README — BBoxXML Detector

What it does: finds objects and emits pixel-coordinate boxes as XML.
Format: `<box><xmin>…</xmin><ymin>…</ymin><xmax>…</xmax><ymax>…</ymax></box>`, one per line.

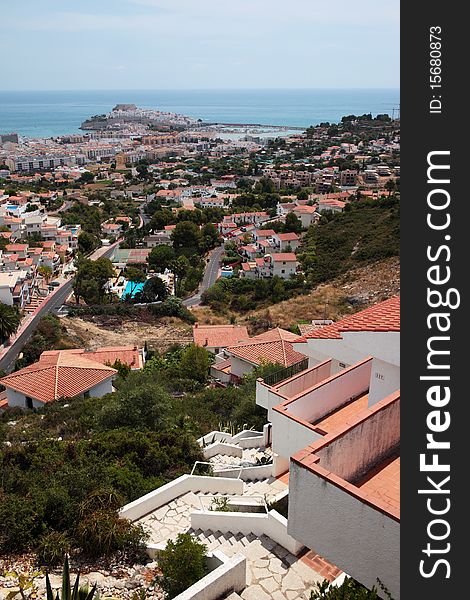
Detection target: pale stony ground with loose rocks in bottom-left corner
<box><xmin>0</xmin><ymin>555</ymin><xmax>164</xmax><ymax>600</ymax></box>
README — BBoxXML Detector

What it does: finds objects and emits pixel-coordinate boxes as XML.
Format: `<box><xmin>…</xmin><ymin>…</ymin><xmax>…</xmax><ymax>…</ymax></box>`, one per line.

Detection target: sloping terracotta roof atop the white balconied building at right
<box><xmin>297</xmin><ymin>296</ymin><xmax>400</xmax><ymax>342</ymax></box>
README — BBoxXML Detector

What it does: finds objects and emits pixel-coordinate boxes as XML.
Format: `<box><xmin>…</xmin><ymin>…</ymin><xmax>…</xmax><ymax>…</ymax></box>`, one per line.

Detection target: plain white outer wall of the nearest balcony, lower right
<box><xmin>288</xmin><ymin>463</ymin><xmax>400</xmax><ymax>600</ymax></box>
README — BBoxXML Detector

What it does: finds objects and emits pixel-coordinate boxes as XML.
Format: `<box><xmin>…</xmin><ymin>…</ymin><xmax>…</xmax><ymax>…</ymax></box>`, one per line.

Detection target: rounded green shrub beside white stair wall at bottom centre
<box><xmin>158</xmin><ymin>533</ymin><xmax>208</xmax><ymax>599</ymax></box>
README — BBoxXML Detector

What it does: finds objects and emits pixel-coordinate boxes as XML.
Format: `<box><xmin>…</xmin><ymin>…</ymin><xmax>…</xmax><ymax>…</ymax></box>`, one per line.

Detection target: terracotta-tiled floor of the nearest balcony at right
<box><xmin>354</xmin><ymin>454</ymin><xmax>400</xmax><ymax>510</ymax></box>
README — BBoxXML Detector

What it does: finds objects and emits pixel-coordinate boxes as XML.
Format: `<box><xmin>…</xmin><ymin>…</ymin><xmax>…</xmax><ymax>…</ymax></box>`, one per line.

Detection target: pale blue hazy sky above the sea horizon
<box><xmin>0</xmin><ymin>0</ymin><xmax>399</xmax><ymax>90</ymax></box>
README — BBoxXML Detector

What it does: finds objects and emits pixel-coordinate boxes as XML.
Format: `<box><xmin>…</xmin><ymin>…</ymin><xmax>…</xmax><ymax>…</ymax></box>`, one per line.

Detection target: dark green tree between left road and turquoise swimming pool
<box><xmin>73</xmin><ymin>258</ymin><xmax>114</xmax><ymax>304</ymax></box>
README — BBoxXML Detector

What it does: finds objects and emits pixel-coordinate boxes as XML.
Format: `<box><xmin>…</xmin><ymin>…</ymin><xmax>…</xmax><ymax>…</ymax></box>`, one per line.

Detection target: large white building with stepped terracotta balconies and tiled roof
<box><xmin>256</xmin><ymin>297</ymin><xmax>400</xmax><ymax>598</ymax></box>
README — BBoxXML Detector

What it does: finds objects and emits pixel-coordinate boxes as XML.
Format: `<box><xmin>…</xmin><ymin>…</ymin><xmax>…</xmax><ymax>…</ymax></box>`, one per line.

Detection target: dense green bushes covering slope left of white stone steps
<box><xmin>0</xmin><ymin>350</ymin><xmax>272</xmax><ymax>564</ymax></box>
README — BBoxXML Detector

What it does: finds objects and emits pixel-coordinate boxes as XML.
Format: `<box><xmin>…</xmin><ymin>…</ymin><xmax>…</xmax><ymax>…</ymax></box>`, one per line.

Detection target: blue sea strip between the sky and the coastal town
<box><xmin>0</xmin><ymin>89</ymin><xmax>400</xmax><ymax>137</ymax></box>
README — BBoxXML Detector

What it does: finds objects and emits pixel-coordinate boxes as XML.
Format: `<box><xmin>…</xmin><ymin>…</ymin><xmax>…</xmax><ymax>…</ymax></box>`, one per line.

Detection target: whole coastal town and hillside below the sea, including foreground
<box><xmin>0</xmin><ymin>103</ymin><xmax>400</xmax><ymax>600</ymax></box>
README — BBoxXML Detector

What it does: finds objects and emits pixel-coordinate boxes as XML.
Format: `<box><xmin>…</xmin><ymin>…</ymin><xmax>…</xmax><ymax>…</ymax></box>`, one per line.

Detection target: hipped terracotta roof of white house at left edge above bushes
<box><xmin>0</xmin><ymin>351</ymin><xmax>117</xmax><ymax>403</ymax></box>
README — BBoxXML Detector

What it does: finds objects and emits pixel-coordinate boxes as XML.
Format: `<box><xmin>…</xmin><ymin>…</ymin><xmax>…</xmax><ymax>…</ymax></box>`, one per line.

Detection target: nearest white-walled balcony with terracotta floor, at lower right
<box><xmin>288</xmin><ymin>391</ymin><xmax>400</xmax><ymax>600</ymax></box>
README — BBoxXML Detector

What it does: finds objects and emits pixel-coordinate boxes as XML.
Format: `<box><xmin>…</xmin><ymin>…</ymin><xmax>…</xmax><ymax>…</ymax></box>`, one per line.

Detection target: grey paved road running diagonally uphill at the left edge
<box><xmin>0</xmin><ymin>242</ymin><xmax>118</xmax><ymax>372</ymax></box>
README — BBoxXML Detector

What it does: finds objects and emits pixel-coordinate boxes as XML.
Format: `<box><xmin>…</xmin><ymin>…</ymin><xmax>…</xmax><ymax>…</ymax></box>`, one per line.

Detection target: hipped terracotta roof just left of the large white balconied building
<box><xmin>227</xmin><ymin>327</ymin><xmax>305</xmax><ymax>367</ymax></box>
